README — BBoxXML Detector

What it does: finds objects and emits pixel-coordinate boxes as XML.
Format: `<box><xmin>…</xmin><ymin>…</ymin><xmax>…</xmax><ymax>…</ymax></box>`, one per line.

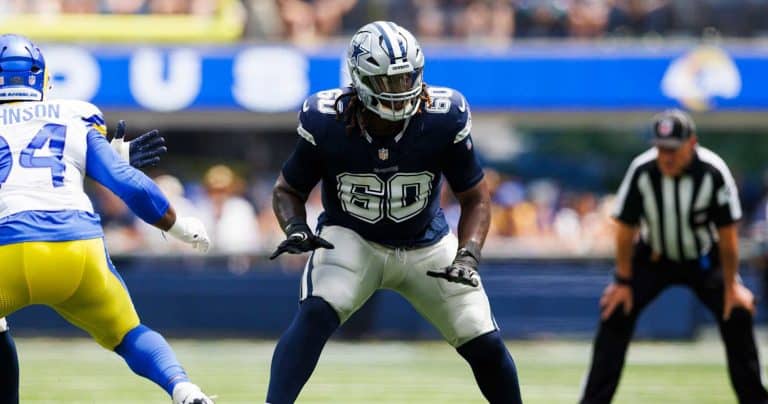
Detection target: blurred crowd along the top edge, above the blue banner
<box><xmin>0</xmin><ymin>0</ymin><xmax>768</xmax><ymax>40</ymax></box>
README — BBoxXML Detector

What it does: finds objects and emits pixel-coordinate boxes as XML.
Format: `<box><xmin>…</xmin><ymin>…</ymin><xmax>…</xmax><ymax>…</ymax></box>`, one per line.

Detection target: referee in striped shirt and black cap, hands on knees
<box><xmin>581</xmin><ymin>110</ymin><xmax>768</xmax><ymax>403</ymax></box>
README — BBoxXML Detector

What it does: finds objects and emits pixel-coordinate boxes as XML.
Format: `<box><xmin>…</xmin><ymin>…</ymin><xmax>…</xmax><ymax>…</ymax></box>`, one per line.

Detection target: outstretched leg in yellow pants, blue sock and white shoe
<box><xmin>52</xmin><ymin>239</ymin><xmax>210</xmax><ymax>404</ymax></box>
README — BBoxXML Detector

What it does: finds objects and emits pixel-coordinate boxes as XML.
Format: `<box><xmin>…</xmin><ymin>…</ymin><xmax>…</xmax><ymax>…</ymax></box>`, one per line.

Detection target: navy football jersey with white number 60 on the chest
<box><xmin>282</xmin><ymin>87</ymin><xmax>483</xmax><ymax>248</ymax></box>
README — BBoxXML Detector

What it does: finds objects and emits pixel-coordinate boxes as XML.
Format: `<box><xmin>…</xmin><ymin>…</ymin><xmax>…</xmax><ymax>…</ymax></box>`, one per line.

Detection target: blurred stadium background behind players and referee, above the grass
<box><xmin>0</xmin><ymin>0</ymin><xmax>768</xmax><ymax>402</ymax></box>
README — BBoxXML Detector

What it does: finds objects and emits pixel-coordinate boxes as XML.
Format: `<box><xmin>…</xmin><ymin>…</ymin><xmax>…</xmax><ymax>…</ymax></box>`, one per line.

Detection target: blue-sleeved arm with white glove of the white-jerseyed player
<box><xmin>86</xmin><ymin>130</ymin><xmax>210</xmax><ymax>252</ymax></box>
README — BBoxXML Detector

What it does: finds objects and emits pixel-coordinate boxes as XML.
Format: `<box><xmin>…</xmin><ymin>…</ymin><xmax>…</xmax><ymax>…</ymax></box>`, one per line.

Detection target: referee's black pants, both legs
<box><xmin>580</xmin><ymin>257</ymin><xmax>768</xmax><ymax>404</ymax></box>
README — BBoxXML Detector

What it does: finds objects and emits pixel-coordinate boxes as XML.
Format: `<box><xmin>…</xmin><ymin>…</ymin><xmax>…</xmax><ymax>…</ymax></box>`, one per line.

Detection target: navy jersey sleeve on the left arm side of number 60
<box><xmin>282</xmin><ymin>95</ymin><xmax>327</xmax><ymax>194</ymax></box>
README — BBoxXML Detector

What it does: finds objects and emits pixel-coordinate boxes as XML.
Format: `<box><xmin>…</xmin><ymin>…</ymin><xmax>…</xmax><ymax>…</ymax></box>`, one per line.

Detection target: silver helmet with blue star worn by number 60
<box><xmin>347</xmin><ymin>21</ymin><xmax>424</xmax><ymax>121</ymax></box>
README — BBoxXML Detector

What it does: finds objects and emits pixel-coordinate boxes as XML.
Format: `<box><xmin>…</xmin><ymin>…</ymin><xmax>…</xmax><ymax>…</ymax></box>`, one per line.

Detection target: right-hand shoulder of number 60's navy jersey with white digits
<box><xmin>424</xmin><ymin>87</ymin><xmax>472</xmax><ymax>143</ymax></box>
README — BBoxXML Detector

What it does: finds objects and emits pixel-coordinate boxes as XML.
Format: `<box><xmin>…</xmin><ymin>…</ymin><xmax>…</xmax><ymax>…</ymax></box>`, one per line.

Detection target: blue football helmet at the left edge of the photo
<box><xmin>0</xmin><ymin>34</ymin><xmax>48</xmax><ymax>102</ymax></box>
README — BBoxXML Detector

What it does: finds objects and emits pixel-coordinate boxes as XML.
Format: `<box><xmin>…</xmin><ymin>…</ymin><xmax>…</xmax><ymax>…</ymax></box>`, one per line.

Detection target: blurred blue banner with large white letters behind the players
<box><xmin>44</xmin><ymin>43</ymin><xmax>768</xmax><ymax>112</ymax></box>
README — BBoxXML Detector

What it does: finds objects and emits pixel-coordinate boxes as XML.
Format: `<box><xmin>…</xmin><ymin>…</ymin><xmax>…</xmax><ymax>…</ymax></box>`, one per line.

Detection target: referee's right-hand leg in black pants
<box><xmin>692</xmin><ymin>269</ymin><xmax>768</xmax><ymax>403</ymax></box>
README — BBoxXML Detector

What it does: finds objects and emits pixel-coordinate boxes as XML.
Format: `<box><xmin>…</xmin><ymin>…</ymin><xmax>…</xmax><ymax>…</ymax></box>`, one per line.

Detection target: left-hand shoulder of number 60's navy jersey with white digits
<box><xmin>296</xmin><ymin>88</ymin><xmax>343</xmax><ymax>146</ymax></box>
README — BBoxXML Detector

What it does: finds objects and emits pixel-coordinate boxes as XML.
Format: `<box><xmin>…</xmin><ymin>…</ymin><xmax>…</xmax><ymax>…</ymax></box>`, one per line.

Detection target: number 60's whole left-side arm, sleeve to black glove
<box><xmin>269</xmin><ymin>107</ymin><xmax>333</xmax><ymax>259</ymax></box>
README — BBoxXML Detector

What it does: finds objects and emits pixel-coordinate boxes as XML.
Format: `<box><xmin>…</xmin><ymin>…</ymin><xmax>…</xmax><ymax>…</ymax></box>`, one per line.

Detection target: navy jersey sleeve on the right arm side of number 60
<box><xmin>442</xmin><ymin>92</ymin><xmax>483</xmax><ymax>192</ymax></box>
